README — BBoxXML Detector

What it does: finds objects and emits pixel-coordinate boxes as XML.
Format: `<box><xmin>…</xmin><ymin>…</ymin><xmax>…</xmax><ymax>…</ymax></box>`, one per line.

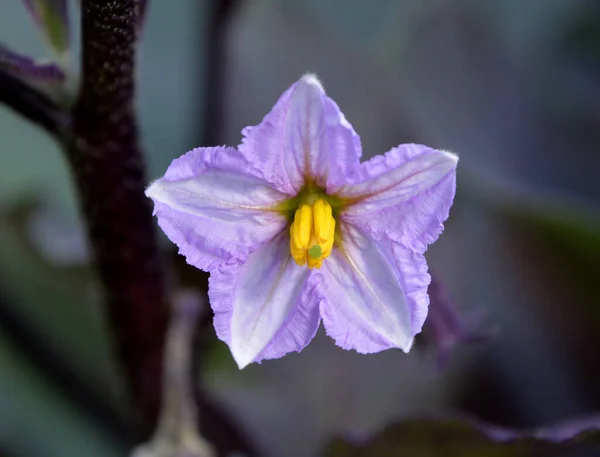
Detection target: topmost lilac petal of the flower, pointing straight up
<box><xmin>239</xmin><ymin>75</ymin><xmax>361</xmax><ymax>195</ymax></box>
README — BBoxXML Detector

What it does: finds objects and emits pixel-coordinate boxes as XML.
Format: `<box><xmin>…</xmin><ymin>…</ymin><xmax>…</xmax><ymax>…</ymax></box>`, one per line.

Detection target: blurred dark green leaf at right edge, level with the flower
<box><xmin>463</xmin><ymin>175</ymin><xmax>600</xmax><ymax>331</ymax></box>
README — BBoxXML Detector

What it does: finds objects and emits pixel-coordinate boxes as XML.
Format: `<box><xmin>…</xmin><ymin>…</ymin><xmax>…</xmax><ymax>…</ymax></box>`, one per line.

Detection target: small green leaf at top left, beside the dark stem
<box><xmin>23</xmin><ymin>0</ymin><xmax>69</xmax><ymax>55</ymax></box>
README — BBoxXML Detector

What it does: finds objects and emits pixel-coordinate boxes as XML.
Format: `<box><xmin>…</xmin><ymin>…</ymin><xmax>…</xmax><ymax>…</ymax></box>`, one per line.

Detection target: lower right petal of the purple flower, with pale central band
<box><xmin>319</xmin><ymin>224</ymin><xmax>429</xmax><ymax>353</ymax></box>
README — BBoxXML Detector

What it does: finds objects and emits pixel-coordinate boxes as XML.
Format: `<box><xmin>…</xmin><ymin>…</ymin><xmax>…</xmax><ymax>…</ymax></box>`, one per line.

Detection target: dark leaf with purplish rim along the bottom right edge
<box><xmin>325</xmin><ymin>416</ymin><xmax>600</xmax><ymax>457</ymax></box>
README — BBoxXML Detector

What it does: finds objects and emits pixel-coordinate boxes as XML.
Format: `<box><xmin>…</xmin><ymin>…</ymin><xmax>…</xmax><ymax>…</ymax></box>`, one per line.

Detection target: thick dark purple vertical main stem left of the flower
<box><xmin>68</xmin><ymin>0</ymin><xmax>168</xmax><ymax>425</ymax></box>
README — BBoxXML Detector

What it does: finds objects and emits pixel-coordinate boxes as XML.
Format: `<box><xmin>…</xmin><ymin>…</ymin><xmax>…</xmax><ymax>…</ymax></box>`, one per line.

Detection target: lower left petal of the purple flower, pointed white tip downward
<box><xmin>208</xmin><ymin>233</ymin><xmax>319</xmax><ymax>369</ymax></box>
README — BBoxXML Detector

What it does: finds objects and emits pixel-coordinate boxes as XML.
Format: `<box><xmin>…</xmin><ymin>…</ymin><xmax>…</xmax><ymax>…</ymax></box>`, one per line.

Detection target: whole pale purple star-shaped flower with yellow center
<box><xmin>146</xmin><ymin>75</ymin><xmax>458</xmax><ymax>368</ymax></box>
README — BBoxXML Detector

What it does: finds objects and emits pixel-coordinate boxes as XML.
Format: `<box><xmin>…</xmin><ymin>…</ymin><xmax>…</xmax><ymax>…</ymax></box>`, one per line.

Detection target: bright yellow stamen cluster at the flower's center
<box><xmin>290</xmin><ymin>198</ymin><xmax>335</xmax><ymax>269</ymax></box>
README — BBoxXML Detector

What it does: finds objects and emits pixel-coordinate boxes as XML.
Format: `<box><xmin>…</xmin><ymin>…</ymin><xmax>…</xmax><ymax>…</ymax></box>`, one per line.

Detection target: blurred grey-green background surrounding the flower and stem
<box><xmin>0</xmin><ymin>0</ymin><xmax>600</xmax><ymax>457</ymax></box>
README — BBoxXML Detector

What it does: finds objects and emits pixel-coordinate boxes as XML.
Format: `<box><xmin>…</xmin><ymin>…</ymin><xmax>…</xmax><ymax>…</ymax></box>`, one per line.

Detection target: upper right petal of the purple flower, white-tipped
<box><xmin>338</xmin><ymin>144</ymin><xmax>458</xmax><ymax>252</ymax></box>
